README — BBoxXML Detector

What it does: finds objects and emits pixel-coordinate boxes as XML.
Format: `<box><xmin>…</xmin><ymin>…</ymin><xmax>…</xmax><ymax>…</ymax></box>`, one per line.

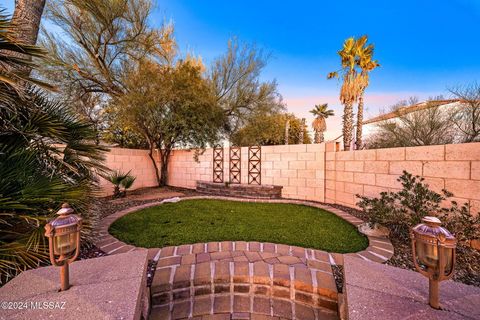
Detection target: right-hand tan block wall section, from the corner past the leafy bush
<box><xmin>325</xmin><ymin>143</ymin><xmax>480</xmax><ymax>213</ymax></box>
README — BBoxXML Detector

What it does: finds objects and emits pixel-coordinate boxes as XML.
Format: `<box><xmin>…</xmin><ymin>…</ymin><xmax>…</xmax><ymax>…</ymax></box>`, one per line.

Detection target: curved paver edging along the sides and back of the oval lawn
<box><xmin>95</xmin><ymin>196</ymin><xmax>394</xmax><ymax>264</ymax></box>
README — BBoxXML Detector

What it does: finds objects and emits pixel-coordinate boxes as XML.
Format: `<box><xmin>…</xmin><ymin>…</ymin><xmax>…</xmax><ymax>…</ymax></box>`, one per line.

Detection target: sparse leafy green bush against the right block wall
<box><xmin>357</xmin><ymin>171</ymin><xmax>480</xmax><ymax>244</ymax></box>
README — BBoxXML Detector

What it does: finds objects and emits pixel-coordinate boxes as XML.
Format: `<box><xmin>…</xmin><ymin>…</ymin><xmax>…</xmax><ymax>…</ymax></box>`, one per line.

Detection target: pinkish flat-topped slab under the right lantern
<box><xmin>344</xmin><ymin>257</ymin><xmax>480</xmax><ymax>320</ymax></box>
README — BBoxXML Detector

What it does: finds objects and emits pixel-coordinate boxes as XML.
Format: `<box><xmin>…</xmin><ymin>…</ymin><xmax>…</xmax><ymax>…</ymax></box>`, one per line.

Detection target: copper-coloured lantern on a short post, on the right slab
<box><xmin>410</xmin><ymin>217</ymin><xmax>457</xmax><ymax>309</ymax></box>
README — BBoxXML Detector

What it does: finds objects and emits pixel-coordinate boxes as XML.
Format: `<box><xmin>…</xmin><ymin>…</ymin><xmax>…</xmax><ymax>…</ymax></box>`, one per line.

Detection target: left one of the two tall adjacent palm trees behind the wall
<box><xmin>327</xmin><ymin>37</ymin><xmax>361</xmax><ymax>150</ymax></box>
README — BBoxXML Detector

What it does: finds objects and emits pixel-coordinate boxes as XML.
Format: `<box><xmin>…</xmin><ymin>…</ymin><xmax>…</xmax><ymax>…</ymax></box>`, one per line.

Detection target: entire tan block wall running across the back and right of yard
<box><xmin>102</xmin><ymin>143</ymin><xmax>480</xmax><ymax>213</ymax></box>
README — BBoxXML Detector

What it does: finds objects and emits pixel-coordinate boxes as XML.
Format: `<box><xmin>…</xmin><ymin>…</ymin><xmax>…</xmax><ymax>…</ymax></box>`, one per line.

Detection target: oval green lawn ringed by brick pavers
<box><xmin>109</xmin><ymin>199</ymin><xmax>368</xmax><ymax>253</ymax></box>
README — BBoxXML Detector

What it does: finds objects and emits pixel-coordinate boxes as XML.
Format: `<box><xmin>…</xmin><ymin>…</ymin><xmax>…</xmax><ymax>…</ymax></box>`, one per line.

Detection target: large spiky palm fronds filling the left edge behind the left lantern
<box><xmin>0</xmin><ymin>6</ymin><xmax>106</xmax><ymax>283</ymax></box>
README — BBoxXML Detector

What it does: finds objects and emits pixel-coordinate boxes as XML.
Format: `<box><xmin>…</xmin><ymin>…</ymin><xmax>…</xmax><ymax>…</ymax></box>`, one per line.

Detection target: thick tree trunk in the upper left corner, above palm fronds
<box><xmin>12</xmin><ymin>0</ymin><xmax>45</xmax><ymax>76</ymax></box>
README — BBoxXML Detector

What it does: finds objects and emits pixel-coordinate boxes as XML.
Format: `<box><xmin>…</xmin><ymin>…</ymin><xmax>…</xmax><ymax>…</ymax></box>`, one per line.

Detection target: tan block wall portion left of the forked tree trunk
<box><xmin>100</xmin><ymin>148</ymin><xmax>159</xmax><ymax>195</ymax></box>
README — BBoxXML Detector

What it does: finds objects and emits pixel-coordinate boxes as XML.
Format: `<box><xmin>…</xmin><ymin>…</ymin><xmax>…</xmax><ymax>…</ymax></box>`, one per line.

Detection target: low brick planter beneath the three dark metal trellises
<box><xmin>196</xmin><ymin>181</ymin><xmax>283</xmax><ymax>199</ymax></box>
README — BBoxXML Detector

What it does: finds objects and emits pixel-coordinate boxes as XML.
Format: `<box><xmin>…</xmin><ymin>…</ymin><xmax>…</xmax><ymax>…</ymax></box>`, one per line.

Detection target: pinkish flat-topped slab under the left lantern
<box><xmin>0</xmin><ymin>250</ymin><xmax>147</xmax><ymax>319</ymax></box>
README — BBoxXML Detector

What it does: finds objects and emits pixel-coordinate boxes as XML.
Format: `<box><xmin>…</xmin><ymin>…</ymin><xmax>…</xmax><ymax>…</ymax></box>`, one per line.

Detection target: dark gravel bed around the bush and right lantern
<box><xmin>327</xmin><ymin>203</ymin><xmax>480</xmax><ymax>287</ymax></box>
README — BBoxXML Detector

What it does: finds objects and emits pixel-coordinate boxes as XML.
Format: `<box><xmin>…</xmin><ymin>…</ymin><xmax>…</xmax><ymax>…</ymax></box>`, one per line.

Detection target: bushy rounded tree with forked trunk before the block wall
<box><xmin>112</xmin><ymin>58</ymin><xmax>224</xmax><ymax>186</ymax></box>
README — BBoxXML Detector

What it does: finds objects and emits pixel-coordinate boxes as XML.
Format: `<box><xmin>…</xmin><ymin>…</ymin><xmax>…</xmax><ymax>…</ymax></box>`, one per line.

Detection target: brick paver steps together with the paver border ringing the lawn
<box><xmin>96</xmin><ymin>196</ymin><xmax>393</xmax><ymax>320</ymax></box>
